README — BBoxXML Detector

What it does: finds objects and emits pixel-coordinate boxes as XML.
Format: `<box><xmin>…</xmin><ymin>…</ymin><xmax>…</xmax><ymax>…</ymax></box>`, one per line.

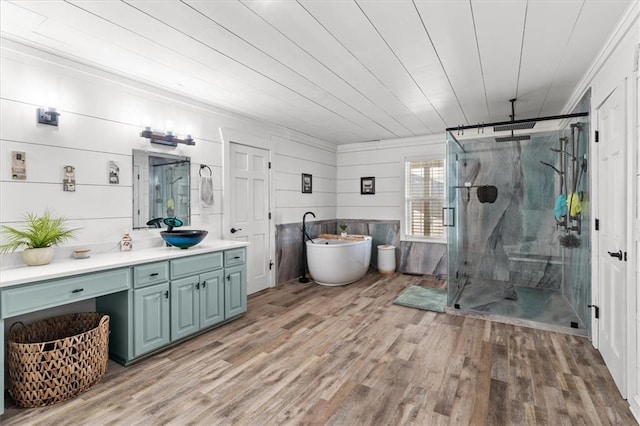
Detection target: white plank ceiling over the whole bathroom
<box><xmin>0</xmin><ymin>0</ymin><xmax>631</xmax><ymax>144</ymax></box>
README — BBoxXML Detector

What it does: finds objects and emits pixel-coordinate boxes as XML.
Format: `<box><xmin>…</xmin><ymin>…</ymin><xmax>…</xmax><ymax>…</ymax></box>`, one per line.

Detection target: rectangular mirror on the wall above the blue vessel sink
<box><xmin>133</xmin><ymin>150</ymin><xmax>191</xmax><ymax>229</ymax></box>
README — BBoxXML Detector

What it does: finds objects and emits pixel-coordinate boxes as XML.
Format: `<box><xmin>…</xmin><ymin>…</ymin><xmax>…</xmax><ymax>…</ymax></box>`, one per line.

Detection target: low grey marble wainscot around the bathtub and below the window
<box><xmin>276</xmin><ymin>219</ymin><xmax>447</xmax><ymax>284</ymax></box>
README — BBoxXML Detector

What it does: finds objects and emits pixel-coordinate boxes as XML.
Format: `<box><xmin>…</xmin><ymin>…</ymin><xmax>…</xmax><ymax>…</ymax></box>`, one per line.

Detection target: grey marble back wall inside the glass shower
<box><xmin>450</xmin><ymin>134</ymin><xmax>562</xmax><ymax>289</ymax></box>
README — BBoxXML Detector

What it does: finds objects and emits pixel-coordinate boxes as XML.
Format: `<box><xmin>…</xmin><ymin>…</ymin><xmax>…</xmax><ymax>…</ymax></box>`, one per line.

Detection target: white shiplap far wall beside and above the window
<box><xmin>336</xmin><ymin>134</ymin><xmax>446</xmax><ymax>220</ymax></box>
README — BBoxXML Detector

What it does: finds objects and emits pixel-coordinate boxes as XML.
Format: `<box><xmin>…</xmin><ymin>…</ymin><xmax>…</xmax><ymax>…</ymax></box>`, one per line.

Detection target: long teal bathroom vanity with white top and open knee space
<box><xmin>0</xmin><ymin>241</ymin><xmax>248</xmax><ymax>414</ymax></box>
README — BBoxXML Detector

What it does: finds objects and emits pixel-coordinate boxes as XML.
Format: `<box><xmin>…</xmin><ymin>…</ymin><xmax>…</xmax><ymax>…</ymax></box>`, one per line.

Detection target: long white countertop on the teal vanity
<box><xmin>0</xmin><ymin>240</ymin><xmax>249</xmax><ymax>288</ymax></box>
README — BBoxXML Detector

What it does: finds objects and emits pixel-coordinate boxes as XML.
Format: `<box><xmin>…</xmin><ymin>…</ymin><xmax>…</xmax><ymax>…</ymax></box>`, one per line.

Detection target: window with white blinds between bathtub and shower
<box><xmin>405</xmin><ymin>159</ymin><xmax>446</xmax><ymax>239</ymax></box>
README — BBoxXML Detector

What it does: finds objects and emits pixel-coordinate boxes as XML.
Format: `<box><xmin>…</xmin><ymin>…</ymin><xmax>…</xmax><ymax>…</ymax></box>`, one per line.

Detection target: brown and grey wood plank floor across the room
<box><xmin>0</xmin><ymin>273</ymin><xmax>636</xmax><ymax>426</ymax></box>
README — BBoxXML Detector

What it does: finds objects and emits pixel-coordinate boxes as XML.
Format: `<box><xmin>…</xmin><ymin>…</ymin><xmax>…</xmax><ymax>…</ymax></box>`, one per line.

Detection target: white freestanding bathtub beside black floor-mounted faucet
<box><xmin>307</xmin><ymin>236</ymin><xmax>371</xmax><ymax>286</ymax></box>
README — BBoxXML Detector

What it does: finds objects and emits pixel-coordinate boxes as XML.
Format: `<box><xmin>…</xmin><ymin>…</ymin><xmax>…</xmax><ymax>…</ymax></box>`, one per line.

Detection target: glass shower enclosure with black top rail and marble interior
<box><xmin>443</xmin><ymin>118</ymin><xmax>590</xmax><ymax>334</ymax></box>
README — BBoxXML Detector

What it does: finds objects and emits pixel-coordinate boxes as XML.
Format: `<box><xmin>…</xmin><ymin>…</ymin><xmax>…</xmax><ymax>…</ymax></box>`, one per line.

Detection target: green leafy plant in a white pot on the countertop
<box><xmin>0</xmin><ymin>209</ymin><xmax>79</xmax><ymax>266</ymax></box>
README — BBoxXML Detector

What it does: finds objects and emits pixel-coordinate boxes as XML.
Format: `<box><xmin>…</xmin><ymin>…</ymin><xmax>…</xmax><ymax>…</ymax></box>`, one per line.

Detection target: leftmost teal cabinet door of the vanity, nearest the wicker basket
<box><xmin>133</xmin><ymin>283</ymin><xmax>170</xmax><ymax>356</ymax></box>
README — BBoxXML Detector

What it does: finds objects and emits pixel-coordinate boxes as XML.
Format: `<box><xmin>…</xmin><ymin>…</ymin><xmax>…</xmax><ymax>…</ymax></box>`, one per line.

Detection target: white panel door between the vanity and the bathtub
<box><xmin>229</xmin><ymin>143</ymin><xmax>271</xmax><ymax>294</ymax></box>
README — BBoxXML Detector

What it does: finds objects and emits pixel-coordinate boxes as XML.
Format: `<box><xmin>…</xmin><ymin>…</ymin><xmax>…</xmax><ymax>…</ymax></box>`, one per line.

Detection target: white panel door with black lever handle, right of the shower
<box><xmin>596</xmin><ymin>86</ymin><xmax>627</xmax><ymax>398</ymax></box>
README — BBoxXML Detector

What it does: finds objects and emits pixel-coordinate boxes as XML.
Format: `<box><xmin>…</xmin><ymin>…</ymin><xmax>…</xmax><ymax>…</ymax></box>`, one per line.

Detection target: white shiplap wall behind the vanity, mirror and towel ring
<box><xmin>0</xmin><ymin>39</ymin><xmax>336</xmax><ymax>267</ymax></box>
